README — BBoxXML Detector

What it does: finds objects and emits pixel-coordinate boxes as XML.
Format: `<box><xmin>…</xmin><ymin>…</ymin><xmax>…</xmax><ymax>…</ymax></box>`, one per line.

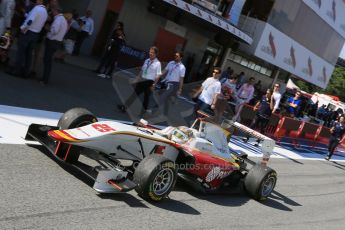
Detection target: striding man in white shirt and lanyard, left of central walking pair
<box><xmin>118</xmin><ymin>46</ymin><xmax>162</xmax><ymax>113</ymax></box>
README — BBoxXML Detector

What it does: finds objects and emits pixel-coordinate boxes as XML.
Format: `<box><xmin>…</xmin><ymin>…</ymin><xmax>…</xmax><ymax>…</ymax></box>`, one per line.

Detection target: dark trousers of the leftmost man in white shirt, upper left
<box><xmin>15</xmin><ymin>31</ymin><xmax>39</xmax><ymax>75</ymax></box>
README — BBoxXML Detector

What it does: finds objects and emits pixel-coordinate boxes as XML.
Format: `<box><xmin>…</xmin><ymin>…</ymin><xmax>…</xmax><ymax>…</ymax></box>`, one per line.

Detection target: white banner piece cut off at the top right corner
<box><xmin>303</xmin><ymin>0</ymin><xmax>345</xmax><ymax>38</ymax></box>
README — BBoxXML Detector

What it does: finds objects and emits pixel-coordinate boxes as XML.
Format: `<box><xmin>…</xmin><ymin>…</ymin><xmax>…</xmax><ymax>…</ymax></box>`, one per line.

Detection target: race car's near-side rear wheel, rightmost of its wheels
<box><xmin>244</xmin><ymin>164</ymin><xmax>277</xmax><ymax>201</ymax></box>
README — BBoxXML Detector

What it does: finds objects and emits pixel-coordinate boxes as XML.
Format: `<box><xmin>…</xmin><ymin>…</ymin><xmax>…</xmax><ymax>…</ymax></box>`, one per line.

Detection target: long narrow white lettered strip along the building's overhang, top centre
<box><xmin>163</xmin><ymin>0</ymin><xmax>253</xmax><ymax>45</ymax></box>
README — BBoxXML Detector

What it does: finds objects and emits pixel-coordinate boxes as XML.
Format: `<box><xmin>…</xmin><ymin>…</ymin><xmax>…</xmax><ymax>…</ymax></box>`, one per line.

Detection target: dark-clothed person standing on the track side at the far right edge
<box><xmin>325</xmin><ymin>116</ymin><xmax>345</xmax><ymax>160</ymax></box>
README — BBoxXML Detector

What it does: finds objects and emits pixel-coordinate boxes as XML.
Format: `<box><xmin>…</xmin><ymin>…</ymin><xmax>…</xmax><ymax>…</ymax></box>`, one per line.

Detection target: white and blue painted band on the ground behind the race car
<box><xmin>0</xmin><ymin>105</ymin><xmax>345</xmax><ymax>162</ymax></box>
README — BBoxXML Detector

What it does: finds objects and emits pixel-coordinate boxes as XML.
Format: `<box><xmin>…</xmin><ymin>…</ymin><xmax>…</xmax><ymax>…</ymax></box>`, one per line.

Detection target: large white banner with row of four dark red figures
<box><xmin>254</xmin><ymin>24</ymin><xmax>334</xmax><ymax>88</ymax></box>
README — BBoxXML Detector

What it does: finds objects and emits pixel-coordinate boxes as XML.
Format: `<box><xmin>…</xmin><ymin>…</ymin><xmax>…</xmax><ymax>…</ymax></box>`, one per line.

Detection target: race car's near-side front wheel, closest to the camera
<box><xmin>133</xmin><ymin>154</ymin><xmax>177</xmax><ymax>201</ymax></box>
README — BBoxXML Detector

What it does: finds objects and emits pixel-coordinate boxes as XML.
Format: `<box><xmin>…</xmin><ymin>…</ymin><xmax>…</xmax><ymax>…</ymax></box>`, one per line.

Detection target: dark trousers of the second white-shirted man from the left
<box><xmin>42</xmin><ymin>38</ymin><xmax>61</xmax><ymax>83</ymax></box>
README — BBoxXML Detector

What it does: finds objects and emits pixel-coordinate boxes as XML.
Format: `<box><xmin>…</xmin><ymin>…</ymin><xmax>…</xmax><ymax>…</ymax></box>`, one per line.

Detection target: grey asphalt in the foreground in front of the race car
<box><xmin>0</xmin><ymin>144</ymin><xmax>345</xmax><ymax>229</ymax></box>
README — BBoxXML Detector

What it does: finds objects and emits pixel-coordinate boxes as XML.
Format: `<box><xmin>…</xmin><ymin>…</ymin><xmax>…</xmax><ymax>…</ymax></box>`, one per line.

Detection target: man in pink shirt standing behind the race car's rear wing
<box><xmin>233</xmin><ymin>77</ymin><xmax>255</xmax><ymax>121</ymax></box>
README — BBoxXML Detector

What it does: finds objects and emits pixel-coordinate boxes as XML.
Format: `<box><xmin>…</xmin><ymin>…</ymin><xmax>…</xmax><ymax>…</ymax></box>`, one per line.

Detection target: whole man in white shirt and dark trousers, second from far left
<box><xmin>40</xmin><ymin>8</ymin><xmax>68</xmax><ymax>85</ymax></box>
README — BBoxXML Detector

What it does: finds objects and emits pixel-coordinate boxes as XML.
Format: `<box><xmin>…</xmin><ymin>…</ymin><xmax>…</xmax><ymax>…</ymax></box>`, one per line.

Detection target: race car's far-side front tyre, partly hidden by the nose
<box><xmin>57</xmin><ymin>108</ymin><xmax>98</xmax><ymax>164</ymax></box>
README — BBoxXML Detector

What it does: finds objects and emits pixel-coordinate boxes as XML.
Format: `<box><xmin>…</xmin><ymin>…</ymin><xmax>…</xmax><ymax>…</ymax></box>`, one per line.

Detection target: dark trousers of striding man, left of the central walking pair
<box><xmin>125</xmin><ymin>80</ymin><xmax>154</xmax><ymax>110</ymax></box>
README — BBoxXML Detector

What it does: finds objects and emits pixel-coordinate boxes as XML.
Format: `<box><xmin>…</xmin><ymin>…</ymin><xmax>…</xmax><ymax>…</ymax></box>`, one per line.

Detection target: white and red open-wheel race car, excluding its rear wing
<box><xmin>25</xmin><ymin>108</ymin><xmax>277</xmax><ymax>201</ymax></box>
